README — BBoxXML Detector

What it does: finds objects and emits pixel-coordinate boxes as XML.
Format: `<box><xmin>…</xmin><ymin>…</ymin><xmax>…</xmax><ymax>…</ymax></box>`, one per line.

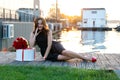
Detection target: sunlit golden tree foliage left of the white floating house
<box><xmin>47</xmin><ymin>4</ymin><xmax>81</xmax><ymax>25</ymax></box>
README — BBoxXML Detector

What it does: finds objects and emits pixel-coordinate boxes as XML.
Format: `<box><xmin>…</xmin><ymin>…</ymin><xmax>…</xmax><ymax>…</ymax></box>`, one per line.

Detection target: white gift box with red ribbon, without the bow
<box><xmin>16</xmin><ymin>48</ymin><xmax>35</xmax><ymax>61</ymax></box>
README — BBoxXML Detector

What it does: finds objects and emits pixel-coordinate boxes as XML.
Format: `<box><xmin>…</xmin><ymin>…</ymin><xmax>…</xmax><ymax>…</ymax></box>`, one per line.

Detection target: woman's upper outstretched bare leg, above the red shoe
<box><xmin>62</xmin><ymin>50</ymin><xmax>91</xmax><ymax>61</ymax></box>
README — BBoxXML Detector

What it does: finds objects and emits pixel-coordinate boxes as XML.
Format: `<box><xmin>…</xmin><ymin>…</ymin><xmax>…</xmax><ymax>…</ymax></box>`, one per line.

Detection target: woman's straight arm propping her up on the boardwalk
<box><xmin>44</xmin><ymin>30</ymin><xmax>52</xmax><ymax>59</ymax></box>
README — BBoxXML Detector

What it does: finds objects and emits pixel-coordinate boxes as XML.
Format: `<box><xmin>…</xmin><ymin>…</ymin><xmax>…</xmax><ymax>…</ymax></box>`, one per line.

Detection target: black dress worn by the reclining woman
<box><xmin>35</xmin><ymin>32</ymin><xmax>65</xmax><ymax>61</ymax></box>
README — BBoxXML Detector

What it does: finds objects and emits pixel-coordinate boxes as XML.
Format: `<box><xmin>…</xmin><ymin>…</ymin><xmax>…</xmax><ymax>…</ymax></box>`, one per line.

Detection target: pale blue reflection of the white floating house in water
<box><xmin>81</xmin><ymin>31</ymin><xmax>105</xmax><ymax>49</ymax></box>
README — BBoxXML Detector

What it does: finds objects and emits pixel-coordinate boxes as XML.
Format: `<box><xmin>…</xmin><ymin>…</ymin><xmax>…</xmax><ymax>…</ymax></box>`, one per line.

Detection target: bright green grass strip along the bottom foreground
<box><xmin>0</xmin><ymin>65</ymin><xmax>119</xmax><ymax>80</ymax></box>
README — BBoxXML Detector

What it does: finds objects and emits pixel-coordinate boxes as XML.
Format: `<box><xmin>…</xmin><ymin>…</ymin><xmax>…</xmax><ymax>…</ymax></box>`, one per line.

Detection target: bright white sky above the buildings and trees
<box><xmin>0</xmin><ymin>0</ymin><xmax>120</xmax><ymax>20</ymax></box>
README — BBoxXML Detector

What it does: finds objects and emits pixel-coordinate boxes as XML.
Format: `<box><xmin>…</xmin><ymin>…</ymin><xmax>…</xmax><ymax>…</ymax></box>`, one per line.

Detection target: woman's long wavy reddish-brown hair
<box><xmin>33</xmin><ymin>17</ymin><xmax>49</xmax><ymax>34</ymax></box>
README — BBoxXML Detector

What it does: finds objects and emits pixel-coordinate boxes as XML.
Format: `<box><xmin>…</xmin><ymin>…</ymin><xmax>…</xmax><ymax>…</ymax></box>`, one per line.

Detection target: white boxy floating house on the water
<box><xmin>81</xmin><ymin>8</ymin><xmax>107</xmax><ymax>28</ymax></box>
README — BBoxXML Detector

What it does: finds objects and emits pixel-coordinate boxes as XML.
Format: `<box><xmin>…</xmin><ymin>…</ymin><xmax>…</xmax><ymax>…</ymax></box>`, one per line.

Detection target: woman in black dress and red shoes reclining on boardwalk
<box><xmin>30</xmin><ymin>17</ymin><xmax>96</xmax><ymax>62</ymax></box>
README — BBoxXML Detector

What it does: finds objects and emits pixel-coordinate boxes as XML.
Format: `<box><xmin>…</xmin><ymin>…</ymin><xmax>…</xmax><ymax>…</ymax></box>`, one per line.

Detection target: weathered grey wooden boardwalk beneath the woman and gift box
<box><xmin>0</xmin><ymin>52</ymin><xmax>120</xmax><ymax>70</ymax></box>
